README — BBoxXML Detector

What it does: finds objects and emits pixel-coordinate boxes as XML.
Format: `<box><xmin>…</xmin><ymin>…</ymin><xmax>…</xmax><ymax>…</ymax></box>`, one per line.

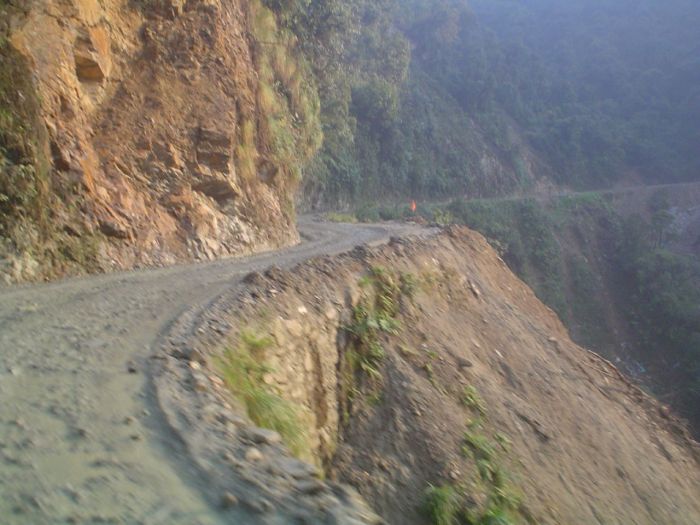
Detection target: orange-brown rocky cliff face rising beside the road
<box><xmin>0</xmin><ymin>0</ymin><xmax>320</xmax><ymax>280</ymax></box>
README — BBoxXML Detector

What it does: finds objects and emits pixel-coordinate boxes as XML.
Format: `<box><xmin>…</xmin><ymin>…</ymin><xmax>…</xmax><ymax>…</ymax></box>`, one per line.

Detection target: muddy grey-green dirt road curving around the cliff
<box><xmin>0</xmin><ymin>219</ymin><xmax>426</xmax><ymax>525</ymax></box>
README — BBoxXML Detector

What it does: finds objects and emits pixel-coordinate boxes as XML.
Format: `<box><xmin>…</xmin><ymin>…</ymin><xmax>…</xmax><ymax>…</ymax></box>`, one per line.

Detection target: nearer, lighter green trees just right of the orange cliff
<box><xmin>266</xmin><ymin>0</ymin><xmax>409</xmax><ymax>201</ymax></box>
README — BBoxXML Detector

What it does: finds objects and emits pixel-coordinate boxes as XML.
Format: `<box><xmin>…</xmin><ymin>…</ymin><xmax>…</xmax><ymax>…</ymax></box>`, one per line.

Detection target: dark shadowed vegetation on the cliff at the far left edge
<box><xmin>0</xmin><ymin>9</ymin><xmax>99</xmax><ymax>277</ymax></box>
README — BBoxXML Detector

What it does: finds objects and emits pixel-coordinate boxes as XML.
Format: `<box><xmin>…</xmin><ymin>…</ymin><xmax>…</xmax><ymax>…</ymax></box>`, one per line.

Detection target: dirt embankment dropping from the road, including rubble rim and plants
<box><xmin>156</xmin><ymin>225</ymin><xmax>700</xmax><ymax>525</ymax></box>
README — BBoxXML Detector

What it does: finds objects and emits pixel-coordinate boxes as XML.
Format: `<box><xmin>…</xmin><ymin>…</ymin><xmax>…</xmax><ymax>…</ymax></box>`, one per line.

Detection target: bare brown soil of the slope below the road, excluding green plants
<box><xmin>185</xmin><ymin>223</ymin><xmax>700</xmax><ymax>525</ymax></box>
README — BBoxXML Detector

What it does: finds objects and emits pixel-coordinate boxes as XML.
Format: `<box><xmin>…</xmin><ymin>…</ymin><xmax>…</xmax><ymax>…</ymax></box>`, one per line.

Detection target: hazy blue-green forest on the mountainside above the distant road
<box><xmin>267</xmin><ymin>0</ymin><xmax>700</xmax><ymax>205</ymax></box>
